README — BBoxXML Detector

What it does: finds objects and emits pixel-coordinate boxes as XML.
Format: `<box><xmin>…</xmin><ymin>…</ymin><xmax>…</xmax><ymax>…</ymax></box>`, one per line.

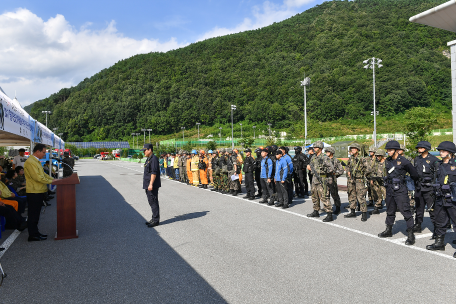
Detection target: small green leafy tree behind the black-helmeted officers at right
<box><xmin>404</xmin><ymin>107</ymin><xmax>437</xmax><ymax>150</ymax></box>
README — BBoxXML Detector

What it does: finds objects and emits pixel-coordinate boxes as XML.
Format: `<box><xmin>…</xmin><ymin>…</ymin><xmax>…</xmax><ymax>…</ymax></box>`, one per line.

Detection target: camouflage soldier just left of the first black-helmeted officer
<box><xmin>368</xmin><ymin>149</ymin><xmax>386</xmax><ymax>214</ymax></box>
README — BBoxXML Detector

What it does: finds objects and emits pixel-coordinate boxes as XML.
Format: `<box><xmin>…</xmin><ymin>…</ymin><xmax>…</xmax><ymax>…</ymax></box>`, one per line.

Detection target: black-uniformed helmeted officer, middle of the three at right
<box><xmin>413</xmin><ymin>141</ymin><xmax>439</xmax><ymax>233</ymax></box>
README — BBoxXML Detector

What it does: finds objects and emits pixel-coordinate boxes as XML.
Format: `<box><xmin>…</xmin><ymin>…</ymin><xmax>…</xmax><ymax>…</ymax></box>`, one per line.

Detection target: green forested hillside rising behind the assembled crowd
<box><xmin>26</xmin><ymin>0</ymin><xmax>456</xmax><ymax>141</ymax></box>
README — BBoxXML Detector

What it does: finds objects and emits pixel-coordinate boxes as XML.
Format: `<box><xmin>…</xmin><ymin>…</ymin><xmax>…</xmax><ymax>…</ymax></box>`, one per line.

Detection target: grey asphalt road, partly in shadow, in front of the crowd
<box><xmin>0</xmin><ymin>160</ymin><xmax>456</xmax><ymax>303</ymax></box>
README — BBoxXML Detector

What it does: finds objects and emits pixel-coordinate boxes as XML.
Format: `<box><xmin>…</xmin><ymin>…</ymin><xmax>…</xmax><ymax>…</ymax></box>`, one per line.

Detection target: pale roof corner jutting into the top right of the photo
<box><xmin>409</xmin><ymin>0</ymin><xmax>456</xmax><ymax>33</ymax></box>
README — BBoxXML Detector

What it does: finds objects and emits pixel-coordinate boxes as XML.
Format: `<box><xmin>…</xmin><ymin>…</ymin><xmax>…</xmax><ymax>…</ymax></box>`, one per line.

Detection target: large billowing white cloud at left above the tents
<box><xmin>0</xmin><ymin>9</ymin><xmax>186</xmax><ymax>106</ymax></box>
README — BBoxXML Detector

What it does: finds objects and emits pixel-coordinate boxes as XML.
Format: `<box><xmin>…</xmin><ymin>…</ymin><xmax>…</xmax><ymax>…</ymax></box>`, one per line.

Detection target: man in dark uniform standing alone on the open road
<box><xmin>141</xmin><ymin>144</ymin><xmax>161</xmax><ymax>228</ymax></box>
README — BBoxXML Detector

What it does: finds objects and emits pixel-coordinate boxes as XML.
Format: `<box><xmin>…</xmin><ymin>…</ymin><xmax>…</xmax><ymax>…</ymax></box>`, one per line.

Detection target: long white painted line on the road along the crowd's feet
<box><xmin>112</xmin><ymin>164</ymin><xmax>456</xmax><ymax>261</ymax></box>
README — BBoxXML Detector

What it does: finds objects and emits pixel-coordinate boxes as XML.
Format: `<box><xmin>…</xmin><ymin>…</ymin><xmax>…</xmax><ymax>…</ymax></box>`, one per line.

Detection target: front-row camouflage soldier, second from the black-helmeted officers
<box><xmin>344</xmin><ymin>143</ymin><xmax>369</xmax><ymax>222</ymax></box>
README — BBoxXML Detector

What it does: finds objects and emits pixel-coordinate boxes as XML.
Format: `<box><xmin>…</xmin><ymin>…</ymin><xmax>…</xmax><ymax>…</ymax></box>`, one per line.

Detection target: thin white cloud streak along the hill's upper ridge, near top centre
<box><xmin>198</xmin><ymin>0</ymin><xmax>315</xmax><ymax>41</ymax></box>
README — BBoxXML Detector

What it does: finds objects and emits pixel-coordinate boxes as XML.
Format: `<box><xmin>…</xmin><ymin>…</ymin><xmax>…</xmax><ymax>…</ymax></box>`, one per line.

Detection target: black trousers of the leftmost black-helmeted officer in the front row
<box><xmin>385</xmin><ymin>185</ymin><xmax>413</xmax><ymax>229</ymax></box>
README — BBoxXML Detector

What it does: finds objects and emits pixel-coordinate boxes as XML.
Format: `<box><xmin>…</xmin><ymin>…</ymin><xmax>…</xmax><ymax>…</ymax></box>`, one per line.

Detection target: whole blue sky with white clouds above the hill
<box><xmin>0</xmin><ymin>0</ymin><xmax>324</xmax><ymax>106</ymax></box>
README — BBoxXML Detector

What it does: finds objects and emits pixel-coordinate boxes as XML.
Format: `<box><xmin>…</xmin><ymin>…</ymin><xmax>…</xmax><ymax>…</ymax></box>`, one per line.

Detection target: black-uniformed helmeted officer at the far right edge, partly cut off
<box><xmin>426</xmin><ymin>141</ymin><xmax>456</xmax><ymax>258</ymax></box>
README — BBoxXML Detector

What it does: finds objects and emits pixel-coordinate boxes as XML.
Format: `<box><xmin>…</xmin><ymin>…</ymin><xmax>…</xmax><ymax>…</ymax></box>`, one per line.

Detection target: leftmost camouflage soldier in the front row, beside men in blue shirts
<box><xmin>307</xmin><ymin>141</ymin><xmax>334</xmax><ymax>222</ymax></box>
